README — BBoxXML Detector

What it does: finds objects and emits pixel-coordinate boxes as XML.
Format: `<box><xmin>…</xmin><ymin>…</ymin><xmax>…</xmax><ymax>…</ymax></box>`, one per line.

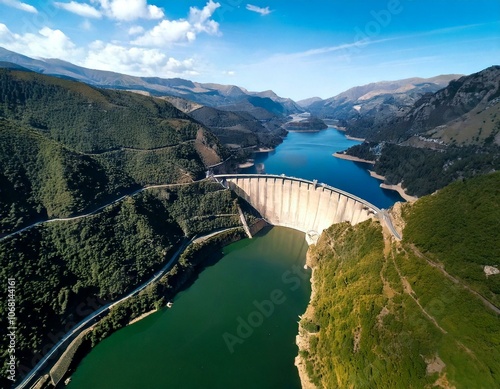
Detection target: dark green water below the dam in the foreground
<box><xmin>68</xmin><ymin>227</ymin><xmax>310</xmax><ymax>389</ymax></box>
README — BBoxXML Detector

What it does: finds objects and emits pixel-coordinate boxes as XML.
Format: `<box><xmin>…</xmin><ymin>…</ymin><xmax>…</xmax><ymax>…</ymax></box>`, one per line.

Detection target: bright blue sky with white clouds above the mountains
<box><xmin>0</xmin><ymin>0</ymin><xmax>500</xmax><ymax>100</ymax></box>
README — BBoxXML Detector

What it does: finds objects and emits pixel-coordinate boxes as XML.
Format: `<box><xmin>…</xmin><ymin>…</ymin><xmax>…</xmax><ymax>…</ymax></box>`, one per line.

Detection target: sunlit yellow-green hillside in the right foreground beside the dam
<box><xmin>300</xmin><ymin>173</ymin><xmax>500</xmax><ymax>388</ymax></box>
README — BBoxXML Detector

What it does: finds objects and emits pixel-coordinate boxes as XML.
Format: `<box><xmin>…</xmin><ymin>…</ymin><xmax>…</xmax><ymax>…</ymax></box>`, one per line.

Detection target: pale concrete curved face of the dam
<box><xmin>214</xmin><ymin>174</ymin><xmax>381</xmax><ymax>235</ymax></box>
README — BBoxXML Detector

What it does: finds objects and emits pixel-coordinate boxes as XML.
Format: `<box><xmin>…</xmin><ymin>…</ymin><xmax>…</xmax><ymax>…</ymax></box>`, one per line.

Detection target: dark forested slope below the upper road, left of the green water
<box><xmin>0</xmin><ymin>181</ymin><xmax>252</xmax><ymax>382</ymax></box>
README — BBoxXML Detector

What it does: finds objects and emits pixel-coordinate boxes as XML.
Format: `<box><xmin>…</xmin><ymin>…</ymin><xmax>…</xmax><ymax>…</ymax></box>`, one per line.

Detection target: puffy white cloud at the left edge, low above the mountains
<box><xmin>0</xmin><ymin>23</ymin><xmax>84</xmax><ymax>61</ymax></box>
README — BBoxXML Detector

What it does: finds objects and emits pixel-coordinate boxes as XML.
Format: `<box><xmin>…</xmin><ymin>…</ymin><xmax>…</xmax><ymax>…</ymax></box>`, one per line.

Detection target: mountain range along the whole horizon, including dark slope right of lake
<box><xmin>0</xmin><ymin>48</ymin><xmax>500</xmax><ymax>196</ymax></box>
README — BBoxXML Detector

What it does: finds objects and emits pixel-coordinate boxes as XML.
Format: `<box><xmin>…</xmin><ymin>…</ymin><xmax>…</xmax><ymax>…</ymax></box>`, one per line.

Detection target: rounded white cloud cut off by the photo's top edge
<box><xmin>91</xmin><ymin>0</ymin><xmax>165</xmax><ymax>21</ymax></box>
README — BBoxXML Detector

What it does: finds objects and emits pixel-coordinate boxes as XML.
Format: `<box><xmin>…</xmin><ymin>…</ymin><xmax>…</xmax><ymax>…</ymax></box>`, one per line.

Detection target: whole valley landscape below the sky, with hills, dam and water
<box><xmin>0</xmin><ymin>49</ymin><xmax>500</xmax><ymax>388</ymax></box>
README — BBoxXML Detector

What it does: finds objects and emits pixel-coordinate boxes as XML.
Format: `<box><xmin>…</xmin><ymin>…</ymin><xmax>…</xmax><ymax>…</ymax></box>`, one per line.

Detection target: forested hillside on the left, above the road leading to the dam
<box><xmin>0</xmin><ymin>69</ymin><xmax>227</xmax><ymax>233</ymax></box>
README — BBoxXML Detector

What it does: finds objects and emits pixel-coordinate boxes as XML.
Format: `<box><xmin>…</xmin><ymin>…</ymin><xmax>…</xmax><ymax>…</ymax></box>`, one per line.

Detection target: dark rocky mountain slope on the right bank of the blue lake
<box><xmin>346</xmin><ymin>66</ymin><xmax>500</xmax><ymax>196</ymax></box>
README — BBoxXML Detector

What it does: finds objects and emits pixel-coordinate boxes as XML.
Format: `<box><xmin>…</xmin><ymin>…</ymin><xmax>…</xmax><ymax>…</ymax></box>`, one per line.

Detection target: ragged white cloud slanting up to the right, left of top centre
<box><xmin>132</xmin><ymin>0</ymin><xmax>220</xmax><ymax>47</ymax></box>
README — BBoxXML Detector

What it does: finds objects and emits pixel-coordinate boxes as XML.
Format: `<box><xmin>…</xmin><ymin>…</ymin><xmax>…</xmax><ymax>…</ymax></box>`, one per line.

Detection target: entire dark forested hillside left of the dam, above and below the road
<box><xmin>0</xmin><ymin>69</ymin><xmax>252</xmax><ymax>387</ymax></box>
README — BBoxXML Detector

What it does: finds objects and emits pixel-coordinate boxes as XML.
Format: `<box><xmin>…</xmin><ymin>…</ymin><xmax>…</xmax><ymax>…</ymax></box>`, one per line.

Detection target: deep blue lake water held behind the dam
<box><xmin>241</xmin><ymin>127</ymin><xmax>404</xmax><ymax>208</ymax></box>
